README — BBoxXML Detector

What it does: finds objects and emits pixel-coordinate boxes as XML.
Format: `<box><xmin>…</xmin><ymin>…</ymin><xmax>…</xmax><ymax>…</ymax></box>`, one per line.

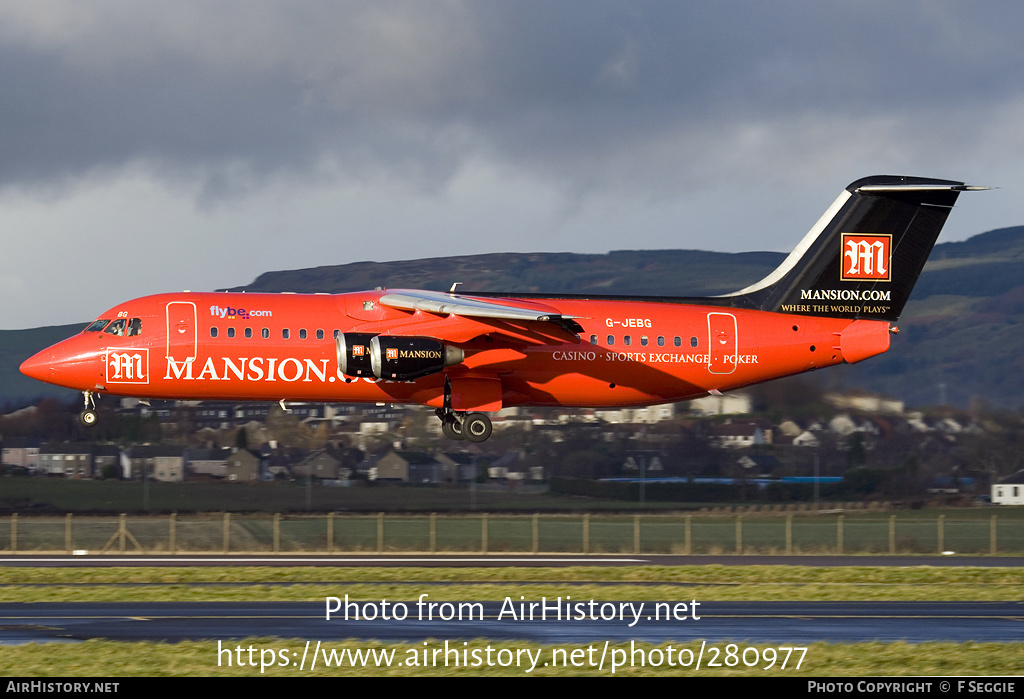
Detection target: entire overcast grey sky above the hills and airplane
<box><xmin>0</xmin><ymin>0</ymin><xmax>1024</xmax><ymax>329</ymax></box>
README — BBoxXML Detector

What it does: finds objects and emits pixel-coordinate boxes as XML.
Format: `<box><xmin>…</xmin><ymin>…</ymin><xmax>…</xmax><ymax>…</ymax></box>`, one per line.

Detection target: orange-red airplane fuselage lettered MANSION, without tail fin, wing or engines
<box><xmin>22</xmin><ymin>291</ymin><xmax>889</xmax><ymax>410</ymax></box>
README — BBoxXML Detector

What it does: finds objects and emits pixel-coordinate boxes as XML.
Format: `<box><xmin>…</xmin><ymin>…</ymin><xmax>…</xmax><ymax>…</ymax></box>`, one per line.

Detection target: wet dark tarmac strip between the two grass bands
<box><xmin>0</xmin><ymin>597</ymin><xmax>1024</xmax><ymax>644</ymax></box>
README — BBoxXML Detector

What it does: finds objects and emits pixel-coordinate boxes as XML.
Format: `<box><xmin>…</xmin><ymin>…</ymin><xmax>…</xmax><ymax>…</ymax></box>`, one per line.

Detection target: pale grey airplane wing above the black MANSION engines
<box><xmin>380</xmin><ymin>289</ymin><xmax>583</xmax><ymax>335</ymax></box>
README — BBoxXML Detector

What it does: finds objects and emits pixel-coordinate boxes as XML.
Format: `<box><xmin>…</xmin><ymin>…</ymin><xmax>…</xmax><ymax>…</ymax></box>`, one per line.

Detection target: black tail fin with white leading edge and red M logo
<box><xmin>728</xmin><ymin>175</ymin><xmax>985</xmax><ymax>321</ymax></box>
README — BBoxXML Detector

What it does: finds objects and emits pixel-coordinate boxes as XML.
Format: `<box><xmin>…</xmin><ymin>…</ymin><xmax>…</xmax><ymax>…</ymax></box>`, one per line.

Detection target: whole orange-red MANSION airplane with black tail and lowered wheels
<box><xmin>20</xmin><ymin>176</ymin><xmax>985</xmax><ymax>442</ymax></box>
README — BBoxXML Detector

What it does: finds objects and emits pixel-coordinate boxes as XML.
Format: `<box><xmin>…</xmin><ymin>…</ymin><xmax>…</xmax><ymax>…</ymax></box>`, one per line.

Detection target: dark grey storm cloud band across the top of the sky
<box><xmin>0</xmin><ymin>0</ymin><xmax>1024</xmax><ymax>193</ymax></box>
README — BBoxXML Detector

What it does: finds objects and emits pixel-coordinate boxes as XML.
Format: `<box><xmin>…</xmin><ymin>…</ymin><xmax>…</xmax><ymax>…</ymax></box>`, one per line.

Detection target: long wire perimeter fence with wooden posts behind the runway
<box><xmin>0</xmin><ymin>513</ymin><xmax>1024</xmax><ymax>555</ymax></box>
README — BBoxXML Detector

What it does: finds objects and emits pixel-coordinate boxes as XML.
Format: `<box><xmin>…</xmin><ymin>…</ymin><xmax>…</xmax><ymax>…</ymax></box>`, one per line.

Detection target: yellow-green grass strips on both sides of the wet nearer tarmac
<box><xmin>0</xmin><ymin>566</ymin><xmax>1024</xmax><ymax>676</ymax></box>
